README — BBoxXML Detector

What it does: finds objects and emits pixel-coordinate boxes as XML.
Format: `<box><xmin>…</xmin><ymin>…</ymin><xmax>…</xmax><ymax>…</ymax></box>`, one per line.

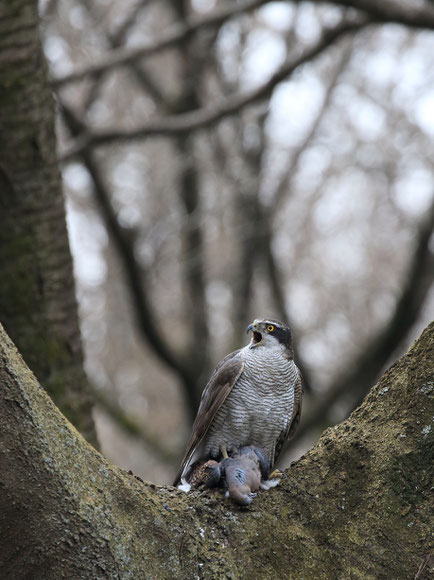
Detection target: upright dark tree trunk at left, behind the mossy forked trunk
<box><xmin>0</xmin><ymin>0</ymin><xmax>96</xmax><ymax>442</ymax></box>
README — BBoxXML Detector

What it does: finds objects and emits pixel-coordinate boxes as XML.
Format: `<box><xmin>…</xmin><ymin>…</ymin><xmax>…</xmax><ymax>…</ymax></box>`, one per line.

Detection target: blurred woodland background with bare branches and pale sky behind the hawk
<box><xmin>40</xmin><ymin>0</ymin><xmax>434</xmax><ymax>483</ymax></box>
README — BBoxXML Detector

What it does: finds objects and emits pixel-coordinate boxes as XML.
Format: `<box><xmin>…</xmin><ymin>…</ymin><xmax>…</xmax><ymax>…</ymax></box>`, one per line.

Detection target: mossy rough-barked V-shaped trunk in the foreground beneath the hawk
<box><xmin>0</xmin><ymin>323</ymin><xmax>434</xmax><ymax>580</ymax></box>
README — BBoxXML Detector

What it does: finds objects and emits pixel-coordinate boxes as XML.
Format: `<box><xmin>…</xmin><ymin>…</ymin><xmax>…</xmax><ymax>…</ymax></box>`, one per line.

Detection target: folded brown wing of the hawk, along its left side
<box><xmin>173</xmin><ymin>350</ymin><xmax>244</xmax><ymax>485</ymax></box>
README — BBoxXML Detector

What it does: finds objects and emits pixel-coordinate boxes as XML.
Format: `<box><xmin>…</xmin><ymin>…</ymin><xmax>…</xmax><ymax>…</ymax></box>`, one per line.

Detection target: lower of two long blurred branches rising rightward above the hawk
<box><xmin>60</xmin><ymin>19</ymin><xmax>368</xmax><ymax>162</ymax></box>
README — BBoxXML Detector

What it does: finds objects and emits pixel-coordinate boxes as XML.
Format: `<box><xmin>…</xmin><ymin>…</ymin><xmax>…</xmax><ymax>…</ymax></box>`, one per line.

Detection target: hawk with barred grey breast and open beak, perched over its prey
<box><xmin>174</xmin><ymin>319</ymin><xmax>302</xmax><ymax>491</ymax></box>
